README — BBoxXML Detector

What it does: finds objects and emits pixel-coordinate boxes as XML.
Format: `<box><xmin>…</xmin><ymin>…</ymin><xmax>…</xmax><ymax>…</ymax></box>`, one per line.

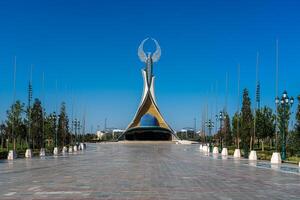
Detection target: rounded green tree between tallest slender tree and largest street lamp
<box><xmin>255</xmin><ymin>106</ymin><xmax>276</xmax><ymax>151</ymax></box>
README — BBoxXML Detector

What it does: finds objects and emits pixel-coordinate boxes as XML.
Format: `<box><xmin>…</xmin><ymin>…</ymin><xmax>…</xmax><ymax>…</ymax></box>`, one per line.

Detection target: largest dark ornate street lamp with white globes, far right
<box><xmin>275</xmin><ymin>90</ymin><xmax>294</xmax><ymax>160</ymax></box>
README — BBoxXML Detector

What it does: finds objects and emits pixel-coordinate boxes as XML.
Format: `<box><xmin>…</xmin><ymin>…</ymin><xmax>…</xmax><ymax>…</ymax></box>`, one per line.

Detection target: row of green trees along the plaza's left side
<box><xmin>0</xmin><ymin>99</ymin><xmax>76</xmax><ymax>152</ymax></box>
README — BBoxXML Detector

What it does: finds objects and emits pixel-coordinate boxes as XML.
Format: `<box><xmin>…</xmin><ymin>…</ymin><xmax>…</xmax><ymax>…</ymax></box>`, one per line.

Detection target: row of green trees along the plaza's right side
<box><xmin>214</xmin><ymin>89</ymin><xmax>300</xmax><ymax>157</ymax></box>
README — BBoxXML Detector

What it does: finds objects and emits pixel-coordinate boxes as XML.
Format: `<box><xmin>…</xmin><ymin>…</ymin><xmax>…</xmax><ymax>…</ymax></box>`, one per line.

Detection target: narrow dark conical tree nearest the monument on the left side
<box><xmin>57</xmin><ymin>102</ymin><xmax>70</xmax><ymax>146</ymax></box>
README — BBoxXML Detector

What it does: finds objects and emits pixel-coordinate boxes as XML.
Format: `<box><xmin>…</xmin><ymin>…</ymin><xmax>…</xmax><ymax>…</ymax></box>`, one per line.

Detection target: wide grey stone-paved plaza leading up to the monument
<box><xmin>0</xmin><ymin>143</ymin><xmax>300</xmax><ymax>199</ymax></box>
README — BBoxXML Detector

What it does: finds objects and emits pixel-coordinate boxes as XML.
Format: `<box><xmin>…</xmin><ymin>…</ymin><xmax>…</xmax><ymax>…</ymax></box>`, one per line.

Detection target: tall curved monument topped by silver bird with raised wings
<box><xmin>120</xmin><ymin>38</ymin><xmax>176</xmax><ymax>141</ymax></box>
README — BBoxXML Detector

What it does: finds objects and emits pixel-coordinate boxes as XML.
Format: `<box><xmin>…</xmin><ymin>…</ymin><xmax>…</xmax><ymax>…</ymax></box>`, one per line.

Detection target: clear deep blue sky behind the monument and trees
<box><xmin>0</xmin><ymin>0</ymin><xmax>300</xmax><ymax>130</ymax></box>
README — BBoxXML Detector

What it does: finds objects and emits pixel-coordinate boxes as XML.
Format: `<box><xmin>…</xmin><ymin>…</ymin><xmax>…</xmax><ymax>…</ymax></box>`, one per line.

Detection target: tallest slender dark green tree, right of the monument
<box><xmin>241</xmin><ymin>89</ymin><xmax>253</xmax><ymax>158</ymax></box>
